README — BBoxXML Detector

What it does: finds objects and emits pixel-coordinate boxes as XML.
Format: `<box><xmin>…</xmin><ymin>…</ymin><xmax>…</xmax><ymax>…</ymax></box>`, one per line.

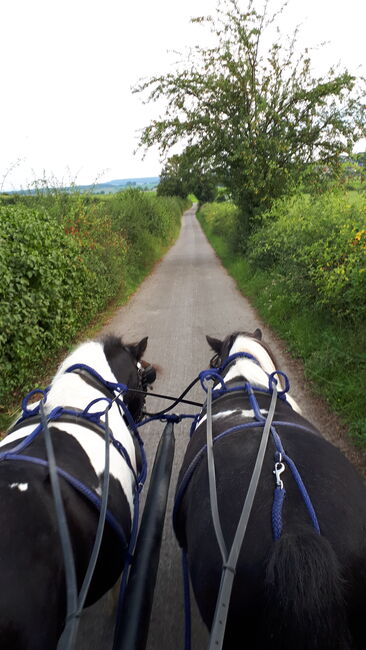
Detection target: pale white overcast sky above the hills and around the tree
<box><xmin>0</xmin><ymin>0</ymin><xmax>366</xmax><ymax>191</ymax></box>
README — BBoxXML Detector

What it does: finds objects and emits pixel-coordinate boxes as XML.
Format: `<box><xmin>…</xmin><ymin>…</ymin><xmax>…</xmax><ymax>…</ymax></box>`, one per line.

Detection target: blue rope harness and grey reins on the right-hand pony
<box><xmin>173</xmin><ymin>353</ymin><xmax>320</xmax><ymax>650</ymax></box>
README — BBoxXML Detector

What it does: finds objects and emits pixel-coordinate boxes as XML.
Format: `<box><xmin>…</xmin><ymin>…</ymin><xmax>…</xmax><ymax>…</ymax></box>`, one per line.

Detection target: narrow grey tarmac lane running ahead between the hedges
<box><xmin>76</xmin><ymin>202</ymin><xmax>364</xmax><ymax>650</ymax></box>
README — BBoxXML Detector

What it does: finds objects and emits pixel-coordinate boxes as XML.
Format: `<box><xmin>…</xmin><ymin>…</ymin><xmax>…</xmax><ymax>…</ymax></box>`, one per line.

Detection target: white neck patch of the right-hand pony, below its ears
<box><xmin>225</xmin><ymin>335</ymin><xmax>276</xmax><ymax>388</ymax></box>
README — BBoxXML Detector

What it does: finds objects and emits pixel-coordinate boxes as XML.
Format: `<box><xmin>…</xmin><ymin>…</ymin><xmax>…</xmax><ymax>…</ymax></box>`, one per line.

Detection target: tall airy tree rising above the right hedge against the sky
<box><xmin>135</xmin><ymin>0</ymin><xmax>366</xmax><ymax>238</ymax></box>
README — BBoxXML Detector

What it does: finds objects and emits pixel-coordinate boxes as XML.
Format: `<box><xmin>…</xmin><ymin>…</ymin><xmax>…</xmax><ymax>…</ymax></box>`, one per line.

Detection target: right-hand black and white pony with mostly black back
<box><xmin>174</xmin><ymin>330</ymin><xmax>366</xmax><ymax>650</ymax></box>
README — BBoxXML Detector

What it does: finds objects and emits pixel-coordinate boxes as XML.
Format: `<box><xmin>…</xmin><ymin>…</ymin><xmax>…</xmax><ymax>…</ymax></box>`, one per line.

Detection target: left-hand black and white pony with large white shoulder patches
<box><xmin>0</xmin><ymin>336</ymin><xmax>151</xmax><ymax>650</ymax></box>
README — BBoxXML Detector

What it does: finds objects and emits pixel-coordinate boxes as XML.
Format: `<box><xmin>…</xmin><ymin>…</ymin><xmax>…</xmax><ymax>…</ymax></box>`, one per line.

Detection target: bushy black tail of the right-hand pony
<box><xmin>263</xmin><ymin>531</ymin><xmax>351</xmax><ymax>650</ymax></box>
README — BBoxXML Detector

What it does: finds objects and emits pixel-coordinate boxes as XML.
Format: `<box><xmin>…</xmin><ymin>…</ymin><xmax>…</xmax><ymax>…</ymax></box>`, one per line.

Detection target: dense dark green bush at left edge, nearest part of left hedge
<box><xmin>0</xmin><ymin>204</ymin><xmax>125</xmax><ymax>403</ymax></box>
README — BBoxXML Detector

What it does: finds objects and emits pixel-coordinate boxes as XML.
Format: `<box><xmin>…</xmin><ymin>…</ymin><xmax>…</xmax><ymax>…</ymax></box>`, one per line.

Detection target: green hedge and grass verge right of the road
<box><xmin>199</xmin><ymin>195</ymin><xmax>366</xmax><ymax>446</ymax></box>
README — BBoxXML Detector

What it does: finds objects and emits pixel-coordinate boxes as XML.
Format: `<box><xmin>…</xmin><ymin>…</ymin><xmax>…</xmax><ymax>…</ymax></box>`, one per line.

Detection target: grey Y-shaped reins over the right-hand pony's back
<box><xmin>207</xmin><ymin>382</ymin><xmax>277</xmax><ymax>650</ymax></box>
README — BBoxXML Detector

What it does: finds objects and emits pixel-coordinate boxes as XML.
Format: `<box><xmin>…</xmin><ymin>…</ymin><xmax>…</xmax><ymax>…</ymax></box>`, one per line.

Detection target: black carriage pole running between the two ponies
<box><xmin>113</xmin><ymin>422</ymin><xmax>175</xmax><ymax>650</ymax></box>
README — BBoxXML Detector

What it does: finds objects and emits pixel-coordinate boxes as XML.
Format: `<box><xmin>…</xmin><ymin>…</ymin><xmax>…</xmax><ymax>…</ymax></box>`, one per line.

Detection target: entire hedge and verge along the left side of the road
<box><xmin>0</xmin><ymin>190</ymin><xmax>189</xmax><ymax>428</ymax></box>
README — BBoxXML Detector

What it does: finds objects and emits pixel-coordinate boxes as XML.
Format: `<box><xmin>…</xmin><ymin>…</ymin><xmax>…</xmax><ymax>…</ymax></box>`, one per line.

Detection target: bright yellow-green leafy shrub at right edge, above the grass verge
<box><xmin>248</xmin><ymin>193</ymin><xmax>366</xmax><ymax>320</ymax></box>
